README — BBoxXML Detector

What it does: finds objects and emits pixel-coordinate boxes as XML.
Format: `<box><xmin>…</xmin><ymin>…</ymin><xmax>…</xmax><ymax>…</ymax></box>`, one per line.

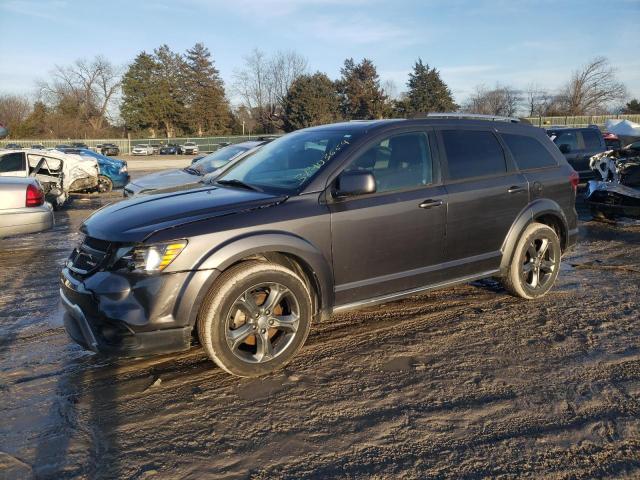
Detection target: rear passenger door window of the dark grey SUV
<box><xmin>441</xmin><ymin>130</ymin><xmax>507</xmax><ymax>180</ymax></box>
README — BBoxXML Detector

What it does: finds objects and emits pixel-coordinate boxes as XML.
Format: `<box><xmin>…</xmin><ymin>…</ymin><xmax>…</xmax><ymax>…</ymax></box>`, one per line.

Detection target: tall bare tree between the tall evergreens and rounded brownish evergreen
<box><xmin>233</xmin><ymin>48</ymin><xmax>307</xmax><ymax>132</ymax></box>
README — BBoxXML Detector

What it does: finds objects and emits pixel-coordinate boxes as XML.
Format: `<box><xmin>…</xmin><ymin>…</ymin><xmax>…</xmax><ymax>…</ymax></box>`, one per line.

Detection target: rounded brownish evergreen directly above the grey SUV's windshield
<box><xmin>283</xmin><ymin>72</ymin><xmax>340</xmax><ymax>132</ymax></box>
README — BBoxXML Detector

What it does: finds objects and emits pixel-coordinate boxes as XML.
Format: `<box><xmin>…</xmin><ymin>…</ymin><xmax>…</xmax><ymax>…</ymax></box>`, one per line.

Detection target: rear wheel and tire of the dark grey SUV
<box><xmin>502</xmin><ymin>222</ymin><xmax>562</xmax><ymax>300</ymax></box>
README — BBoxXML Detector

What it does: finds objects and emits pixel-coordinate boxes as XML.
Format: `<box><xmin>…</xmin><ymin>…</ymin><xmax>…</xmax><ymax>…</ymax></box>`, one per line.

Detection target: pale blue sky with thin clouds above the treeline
<box><xmin>0</xmin><ymin>0</ymin><xmax>640</xmax><ymax>107</ymax></box>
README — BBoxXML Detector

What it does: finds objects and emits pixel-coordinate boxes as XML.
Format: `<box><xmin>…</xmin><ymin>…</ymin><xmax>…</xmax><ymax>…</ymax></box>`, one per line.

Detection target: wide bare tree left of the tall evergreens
<box><xmin>39</xmin><ymin>55</ymin><xmax>121</xmax><ymax>132</ymax></box>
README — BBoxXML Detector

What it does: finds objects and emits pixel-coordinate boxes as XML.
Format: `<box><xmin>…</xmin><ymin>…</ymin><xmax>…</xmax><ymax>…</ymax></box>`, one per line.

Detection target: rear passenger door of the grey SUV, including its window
<box><xmin>438</xmin><ymin>127</ymin><xmax>529</xmax><ymax>277</ymax></box>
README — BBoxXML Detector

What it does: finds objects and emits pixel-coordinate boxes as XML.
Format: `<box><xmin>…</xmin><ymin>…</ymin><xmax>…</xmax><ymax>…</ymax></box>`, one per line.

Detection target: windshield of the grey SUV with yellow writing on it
<box><xmin>217</xmin><ymin>130</ymin><xmax>356</xmax><ymax>194</ymax></box>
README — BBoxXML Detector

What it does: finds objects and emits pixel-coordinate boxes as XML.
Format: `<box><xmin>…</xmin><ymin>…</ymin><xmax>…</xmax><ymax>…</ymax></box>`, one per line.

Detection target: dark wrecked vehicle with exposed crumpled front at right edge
<box><xmin>586</xmin><ymin>149</ymin><xmax>640</xmax><ymax>219</ymax></box>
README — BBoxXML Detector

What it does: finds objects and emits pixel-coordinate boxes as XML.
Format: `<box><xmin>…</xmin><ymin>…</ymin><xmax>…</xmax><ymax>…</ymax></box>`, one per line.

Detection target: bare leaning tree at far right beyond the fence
<box><xmin>561</xmin><ymin>57</ymin><xmax>627</xmax><ymax>115</ymax></box>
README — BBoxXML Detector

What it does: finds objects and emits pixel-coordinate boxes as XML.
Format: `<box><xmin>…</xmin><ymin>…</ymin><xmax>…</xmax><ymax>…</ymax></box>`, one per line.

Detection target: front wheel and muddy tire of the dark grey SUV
<box><xmin>197</xmin><ymin>261</ymin><xmax>313</xmax><ymax>377</ymax></box>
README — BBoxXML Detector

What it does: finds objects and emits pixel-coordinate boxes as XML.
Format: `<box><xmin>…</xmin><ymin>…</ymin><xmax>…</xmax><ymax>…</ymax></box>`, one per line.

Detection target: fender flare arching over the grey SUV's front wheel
<box><xmin>176</xmin><ymin>232</ymin><xmax>334</xmax><ymax>325</ymax></box>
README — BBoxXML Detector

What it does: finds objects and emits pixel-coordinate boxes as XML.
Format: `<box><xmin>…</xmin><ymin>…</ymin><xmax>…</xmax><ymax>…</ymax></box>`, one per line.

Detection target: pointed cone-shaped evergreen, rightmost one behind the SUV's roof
<box><xmin>403</xmin><ymin>58</ymin><xmax>458</xmax><ymax>114</ymax></box>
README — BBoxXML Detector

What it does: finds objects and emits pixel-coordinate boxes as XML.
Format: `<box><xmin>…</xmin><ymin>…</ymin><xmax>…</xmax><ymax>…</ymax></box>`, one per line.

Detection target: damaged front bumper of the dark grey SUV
<box><xmin>60</xmin><ymin>267</ymin><xmax>193</xmax><ymax>356</ymax></box>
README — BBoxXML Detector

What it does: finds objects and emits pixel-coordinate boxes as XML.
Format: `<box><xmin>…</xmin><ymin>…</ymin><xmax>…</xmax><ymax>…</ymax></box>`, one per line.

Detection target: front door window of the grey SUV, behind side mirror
<box><xmin>345</xmin><ymin>132</ymin><xmax>433</xmax><ymax>192</ymax></box>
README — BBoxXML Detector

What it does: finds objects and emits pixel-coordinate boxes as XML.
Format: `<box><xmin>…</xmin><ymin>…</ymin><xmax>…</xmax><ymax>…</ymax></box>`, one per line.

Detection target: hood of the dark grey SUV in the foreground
<box><xmin>81</xmin><ymin>186</ymin><xmax>286</xmax><ymax>242</ymax></box>
